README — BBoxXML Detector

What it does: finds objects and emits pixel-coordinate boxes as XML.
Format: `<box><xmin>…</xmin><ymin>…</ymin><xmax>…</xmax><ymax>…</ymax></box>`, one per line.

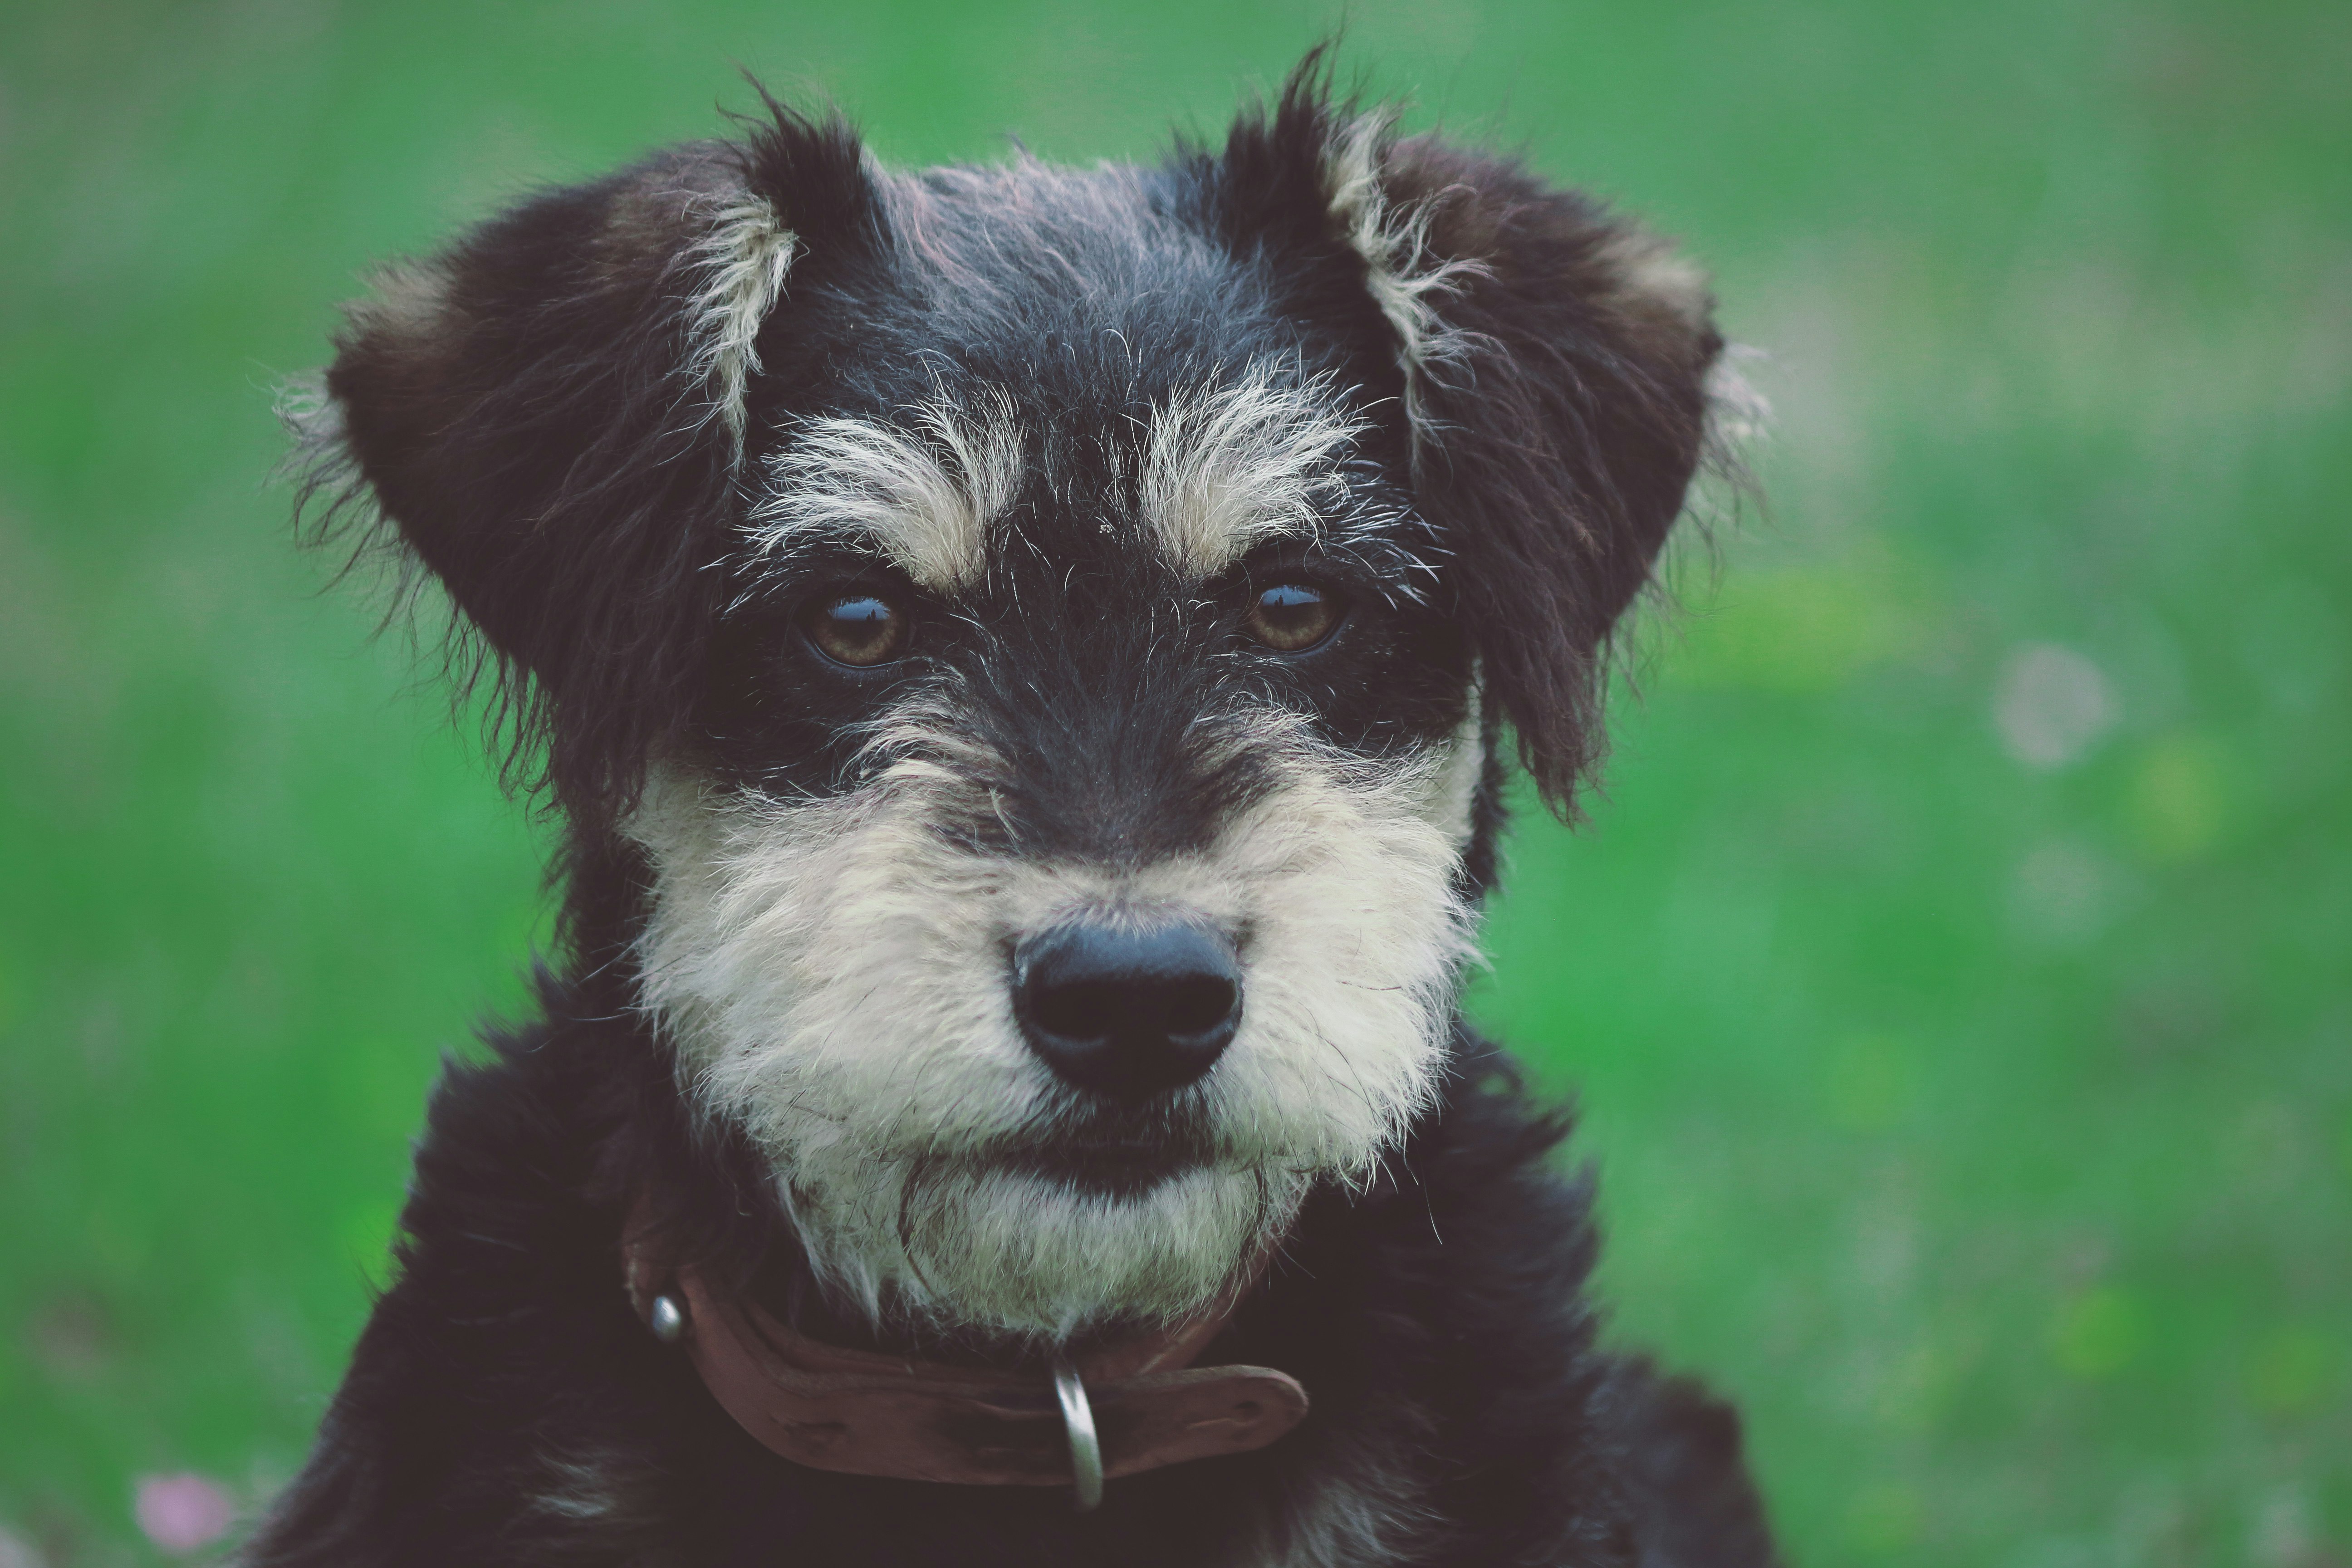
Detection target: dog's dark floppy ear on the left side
<box><xmin>306</xmin><ymin>103</ymin><xmax>875</xmax><ymax>813</ymax></box>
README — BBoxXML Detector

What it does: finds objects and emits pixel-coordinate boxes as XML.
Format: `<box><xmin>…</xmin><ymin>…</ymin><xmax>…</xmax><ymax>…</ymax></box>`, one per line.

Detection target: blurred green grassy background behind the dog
<box><xmin>0</xmin><ymin>0</ymin><xmax>2352</xmax><ymax>1568</ymax></box>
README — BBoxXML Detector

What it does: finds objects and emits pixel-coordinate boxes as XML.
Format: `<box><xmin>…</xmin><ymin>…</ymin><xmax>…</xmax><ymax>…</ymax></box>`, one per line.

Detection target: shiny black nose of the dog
<box><xmin>1014</xmin><ymin>921</ymin><xmax>1242</xmax><ymax>1098</ymax></box>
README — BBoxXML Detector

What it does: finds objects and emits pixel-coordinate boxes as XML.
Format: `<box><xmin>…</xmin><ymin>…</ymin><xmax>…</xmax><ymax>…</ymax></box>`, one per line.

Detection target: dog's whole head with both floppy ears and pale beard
<box><xmin>303</xmin><ymin>73</ymin><xmax>1717</xmax><ymax>1335</ymax></box>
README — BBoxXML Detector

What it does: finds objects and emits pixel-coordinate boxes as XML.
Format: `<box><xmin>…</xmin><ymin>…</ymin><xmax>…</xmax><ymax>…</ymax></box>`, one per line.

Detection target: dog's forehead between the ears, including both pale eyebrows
<box><xmin>750</xmin><ymin>162</ymin><xmax>1381</xmax><ymax>595</ymax></box>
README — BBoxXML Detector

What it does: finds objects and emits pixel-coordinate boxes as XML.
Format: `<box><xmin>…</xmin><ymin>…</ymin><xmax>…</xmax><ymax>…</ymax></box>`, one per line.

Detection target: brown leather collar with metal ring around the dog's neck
<box><xmin>626</xmin><ymin>1225</ymin><xmax>1308</xmax><ymax>1495</ymax></box>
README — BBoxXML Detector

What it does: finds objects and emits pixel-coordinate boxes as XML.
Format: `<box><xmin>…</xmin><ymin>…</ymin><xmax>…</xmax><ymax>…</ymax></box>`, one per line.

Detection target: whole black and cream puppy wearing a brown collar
<box><xmin>245</xmin><ymin>61</ymin><xmax>1774</xmax><ymax>1568</ymax></box>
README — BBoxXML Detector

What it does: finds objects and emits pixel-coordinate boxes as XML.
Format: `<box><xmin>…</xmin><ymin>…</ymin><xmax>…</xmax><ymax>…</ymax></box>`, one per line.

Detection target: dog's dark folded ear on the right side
<box><xmin>1223</xmin><ymin>54</ymin><xmax>1722</xmax><ymax>818</ymax></box>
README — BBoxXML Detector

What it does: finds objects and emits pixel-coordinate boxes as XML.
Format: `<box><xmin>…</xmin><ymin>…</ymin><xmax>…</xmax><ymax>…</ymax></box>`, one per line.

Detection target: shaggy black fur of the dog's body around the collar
<box><xmin>247</xmin><ymin>980</ymin><xmax>1771</xmax><ymax>1568</ymax></box>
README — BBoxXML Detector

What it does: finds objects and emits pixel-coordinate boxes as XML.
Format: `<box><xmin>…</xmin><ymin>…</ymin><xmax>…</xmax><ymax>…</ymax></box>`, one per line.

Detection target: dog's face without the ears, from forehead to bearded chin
<box><xmin>626</xmin><ymin>333</ymin><xmax>1484</xmax><ymax>1333</ymax></box>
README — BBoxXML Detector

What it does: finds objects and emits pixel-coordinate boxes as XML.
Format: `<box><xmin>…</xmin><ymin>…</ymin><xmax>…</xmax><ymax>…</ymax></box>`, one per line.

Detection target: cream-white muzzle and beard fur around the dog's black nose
<box><xmin>628</xmin><ymin>717</ymin><xmax>1482</xmax><ymax>1340</ymax></box>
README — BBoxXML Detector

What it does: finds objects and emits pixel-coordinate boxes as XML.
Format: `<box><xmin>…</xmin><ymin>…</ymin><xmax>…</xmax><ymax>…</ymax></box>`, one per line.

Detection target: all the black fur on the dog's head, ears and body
<box><xmin>262</xmin><ymin>61</ymin><xmax>1771</xmax><ymax>1568</ymax></box>
